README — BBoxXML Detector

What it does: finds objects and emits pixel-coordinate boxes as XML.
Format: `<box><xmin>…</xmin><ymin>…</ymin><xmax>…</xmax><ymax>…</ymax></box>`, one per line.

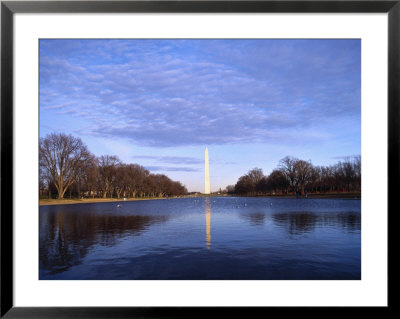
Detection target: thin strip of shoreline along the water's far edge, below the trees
<box><xmin>39</xmin><ymin>193</ymin><xmax>361</xmax><ymax>206</ymax></box>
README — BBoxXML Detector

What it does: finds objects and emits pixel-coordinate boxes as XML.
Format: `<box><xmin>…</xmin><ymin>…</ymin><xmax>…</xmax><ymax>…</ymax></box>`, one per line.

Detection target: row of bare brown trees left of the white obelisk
<box><xmin>39</xmin><ymin>133</ymin><xmax>187</xmax><ymax>199</ymax></box>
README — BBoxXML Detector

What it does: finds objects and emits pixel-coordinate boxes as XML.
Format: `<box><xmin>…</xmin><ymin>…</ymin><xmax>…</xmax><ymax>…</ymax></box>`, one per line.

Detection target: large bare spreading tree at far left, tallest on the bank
<box><xmin>39</xmin><ymin>133</ymin><xmax>91</xmax><ymax>199</ymax></box>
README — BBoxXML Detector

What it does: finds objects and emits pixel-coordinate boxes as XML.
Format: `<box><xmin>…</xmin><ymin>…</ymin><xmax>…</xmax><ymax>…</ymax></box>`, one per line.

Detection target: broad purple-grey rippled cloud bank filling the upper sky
<box><xmin>40</xmin><ymin>40</ymin><xmax>361</xmax><ymax>149</ymax></box>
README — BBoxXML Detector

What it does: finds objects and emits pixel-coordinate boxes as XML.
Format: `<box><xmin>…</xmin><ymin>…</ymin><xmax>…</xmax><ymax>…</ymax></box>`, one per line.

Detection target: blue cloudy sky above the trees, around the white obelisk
<box><xmin>39</xmin><ymin>39</ymin><xmax>361</xmax><ymax>191</ymax></box>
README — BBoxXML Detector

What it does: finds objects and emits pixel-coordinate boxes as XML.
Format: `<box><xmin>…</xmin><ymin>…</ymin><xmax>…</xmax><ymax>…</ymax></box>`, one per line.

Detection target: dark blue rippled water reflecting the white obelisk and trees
<box><xmin>39</xmin><ymin>197</ymin><xmax>361</xmax><ymax>280</ymax></box>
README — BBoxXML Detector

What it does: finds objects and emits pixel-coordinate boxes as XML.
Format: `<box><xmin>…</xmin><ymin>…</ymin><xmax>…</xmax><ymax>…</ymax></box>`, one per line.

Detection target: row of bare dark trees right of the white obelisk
<box><xmin>227</xmin><ymin>156</ymin><xmax>361</xmax><ymax>196</ymax></box>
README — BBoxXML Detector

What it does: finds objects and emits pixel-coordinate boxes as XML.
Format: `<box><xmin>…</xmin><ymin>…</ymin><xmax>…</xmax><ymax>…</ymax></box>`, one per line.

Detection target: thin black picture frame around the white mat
<box><xmin>0</xmin><ymin>0</ymin><xmax>394</xmax><ymax>318</ymax></box>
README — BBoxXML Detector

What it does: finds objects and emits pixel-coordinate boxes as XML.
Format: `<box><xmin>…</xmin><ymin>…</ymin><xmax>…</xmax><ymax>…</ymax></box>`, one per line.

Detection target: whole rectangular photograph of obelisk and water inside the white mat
<box><xmin>38</xmin><ymin>38</ymin><xmax>362</xmax><ymax>281</ymax></box>
